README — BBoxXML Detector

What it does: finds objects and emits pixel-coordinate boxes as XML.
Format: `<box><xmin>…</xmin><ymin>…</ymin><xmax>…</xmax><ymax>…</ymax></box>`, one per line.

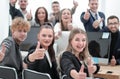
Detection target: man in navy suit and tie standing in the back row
<box><xmin>80</xmin><ymin>0</ymin><xmax>105</xmax><ymax>32</ymax></box>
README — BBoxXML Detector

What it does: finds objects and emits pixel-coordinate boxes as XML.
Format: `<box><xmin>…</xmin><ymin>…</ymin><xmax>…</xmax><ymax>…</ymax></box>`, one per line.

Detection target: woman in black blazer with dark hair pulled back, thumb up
<box><xmin>24</xmin><ymin>24</ymin><xmax>59</xmax><ymax>79</ymax></box>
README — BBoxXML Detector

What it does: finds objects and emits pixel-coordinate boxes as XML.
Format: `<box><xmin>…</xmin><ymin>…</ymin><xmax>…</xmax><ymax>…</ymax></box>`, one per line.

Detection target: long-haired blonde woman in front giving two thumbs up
<box><xmin>60</xmin><ymin>28</ymin><xmax>99</xmax><ymax>79</ymax></box>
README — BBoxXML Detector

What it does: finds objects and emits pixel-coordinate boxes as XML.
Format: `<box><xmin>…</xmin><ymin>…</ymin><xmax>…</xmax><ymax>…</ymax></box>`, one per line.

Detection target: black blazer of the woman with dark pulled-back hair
<box><xmin>24</xmin><ymin>45</ymin><xmax>59</xmax><ymax>79</ymax></box>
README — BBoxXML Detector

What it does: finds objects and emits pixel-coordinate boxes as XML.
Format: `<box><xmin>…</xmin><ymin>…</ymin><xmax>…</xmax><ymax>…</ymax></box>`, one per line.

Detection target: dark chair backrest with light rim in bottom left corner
<box><xmin>0</xmin><ymin>66</ymin><xmax>18</xmax><ymax>79</ymax></box>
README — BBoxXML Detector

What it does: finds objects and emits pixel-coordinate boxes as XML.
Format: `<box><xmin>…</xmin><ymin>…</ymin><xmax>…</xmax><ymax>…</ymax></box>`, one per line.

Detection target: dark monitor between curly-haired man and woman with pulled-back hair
<box><xmin>20</xmin><ymin>26</ymin><xmax>40</xmax><ymax>51</ymax></box>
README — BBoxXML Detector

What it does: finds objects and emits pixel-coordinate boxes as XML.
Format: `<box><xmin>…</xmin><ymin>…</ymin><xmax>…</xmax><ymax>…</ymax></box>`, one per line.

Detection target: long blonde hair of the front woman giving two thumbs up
<box><xmin>66</xmin><ymin>28</ymin><xmax>90</xmax><ymax>60</ymax></box>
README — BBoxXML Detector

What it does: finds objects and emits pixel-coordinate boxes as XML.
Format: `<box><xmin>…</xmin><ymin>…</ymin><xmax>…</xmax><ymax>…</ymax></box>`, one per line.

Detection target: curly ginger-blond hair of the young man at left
<box><xmin>10</xmin><ymin>17</ymin><xmax>30</xmax><ymax>32</ymax></box>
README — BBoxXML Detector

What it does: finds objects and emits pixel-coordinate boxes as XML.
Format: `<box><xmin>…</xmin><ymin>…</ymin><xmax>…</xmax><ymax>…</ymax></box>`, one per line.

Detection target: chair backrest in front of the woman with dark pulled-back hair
<box><xmin>22</xmin><ymin>69</ymin><xmax>51</xmax><ymax>79</ymax></box>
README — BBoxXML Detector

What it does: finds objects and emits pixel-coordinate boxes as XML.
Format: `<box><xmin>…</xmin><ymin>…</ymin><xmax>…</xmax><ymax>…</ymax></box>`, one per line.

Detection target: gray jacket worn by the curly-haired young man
<box><xmin>0</xmin><ymin>37</ymin><xmax>23</xmax><ymax>76</ymax></box>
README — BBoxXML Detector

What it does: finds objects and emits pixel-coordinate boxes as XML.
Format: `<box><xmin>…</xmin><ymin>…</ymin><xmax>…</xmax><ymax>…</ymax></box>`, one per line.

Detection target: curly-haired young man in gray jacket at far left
<box><xmin>0</xmin><ymin>17</ymin><xmax>30</xmax><ymax>79</ymax></box>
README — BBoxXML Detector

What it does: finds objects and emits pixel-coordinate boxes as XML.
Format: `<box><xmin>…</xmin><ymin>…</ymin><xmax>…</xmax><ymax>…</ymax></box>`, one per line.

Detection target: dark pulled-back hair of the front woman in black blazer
<box><xmin>39</xmin><ymin>24</ymin><xmax>55</xmax><ymax>61</ymax></box>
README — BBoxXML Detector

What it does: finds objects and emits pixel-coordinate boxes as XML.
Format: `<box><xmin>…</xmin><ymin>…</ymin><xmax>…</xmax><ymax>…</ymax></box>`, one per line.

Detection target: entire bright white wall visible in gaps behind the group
<box><xmin>0</xmin><ymin>0</ymin><xmax>120</xmax><ymax>42</ymax></box>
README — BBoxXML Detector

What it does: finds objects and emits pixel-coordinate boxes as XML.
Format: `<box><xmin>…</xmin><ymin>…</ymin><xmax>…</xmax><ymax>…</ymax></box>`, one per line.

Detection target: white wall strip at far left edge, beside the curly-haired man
<box><xmin>0</xmin><ymin>0</ymin><xmax>9</xmax><ymax>43</ymax></box>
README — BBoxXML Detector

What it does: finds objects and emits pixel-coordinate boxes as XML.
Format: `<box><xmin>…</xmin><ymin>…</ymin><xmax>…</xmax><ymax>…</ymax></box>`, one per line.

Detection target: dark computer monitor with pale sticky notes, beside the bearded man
<box><xmin>87</xmin><ymin>32</ymin><xmax>111</xmax><ymax>65</ymax></box>
